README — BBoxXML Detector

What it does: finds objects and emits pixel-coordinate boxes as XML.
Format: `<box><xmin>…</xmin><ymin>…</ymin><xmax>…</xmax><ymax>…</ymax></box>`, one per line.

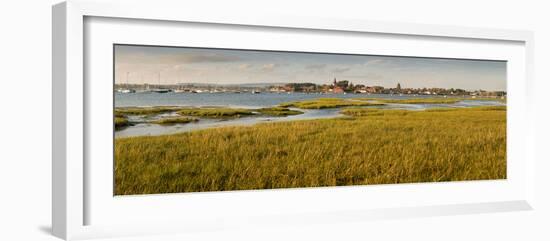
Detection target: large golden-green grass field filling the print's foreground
<box><xmin>115</xmin><ymin>107</ymin><xmax>506</xmax><ymax>195</ymax></box>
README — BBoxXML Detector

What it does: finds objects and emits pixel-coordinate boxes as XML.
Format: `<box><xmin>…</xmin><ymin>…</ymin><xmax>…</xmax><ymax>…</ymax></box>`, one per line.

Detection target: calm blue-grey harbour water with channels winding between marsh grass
<box><xmin>115</xmin><ymin>93</ymin><xmax>504</xmax><ymax>137</ymax></box>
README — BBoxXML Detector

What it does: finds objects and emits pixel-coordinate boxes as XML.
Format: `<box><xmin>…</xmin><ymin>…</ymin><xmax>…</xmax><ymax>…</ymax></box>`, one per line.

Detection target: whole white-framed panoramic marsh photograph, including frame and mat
<box><xmin>52</xmin><ymin>0</ymin><xmax>535</xmax><ymax>239</ymax></box>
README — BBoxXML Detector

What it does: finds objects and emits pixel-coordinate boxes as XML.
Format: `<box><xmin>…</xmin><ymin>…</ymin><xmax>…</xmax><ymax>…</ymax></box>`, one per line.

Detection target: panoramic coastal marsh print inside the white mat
<box><xmin>113</xmin><ymin>44</ymin><xmax>506</xmax><ymax>195</ymax></box>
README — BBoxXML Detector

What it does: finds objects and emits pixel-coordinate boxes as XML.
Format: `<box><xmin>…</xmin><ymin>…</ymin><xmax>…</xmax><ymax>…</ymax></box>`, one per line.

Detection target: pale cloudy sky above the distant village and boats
<box><xmin>114</xmin><ymin>45</ymin><xmax>506</xmax><ymax>91</ymax></box>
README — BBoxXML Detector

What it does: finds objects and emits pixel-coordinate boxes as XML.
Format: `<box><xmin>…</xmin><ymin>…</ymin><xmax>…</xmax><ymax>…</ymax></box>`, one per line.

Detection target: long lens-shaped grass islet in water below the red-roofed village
<box><xmin>279</xmin><ymin>98</ymin><xmax>384</xmax><ymax>109</ymax></box>
